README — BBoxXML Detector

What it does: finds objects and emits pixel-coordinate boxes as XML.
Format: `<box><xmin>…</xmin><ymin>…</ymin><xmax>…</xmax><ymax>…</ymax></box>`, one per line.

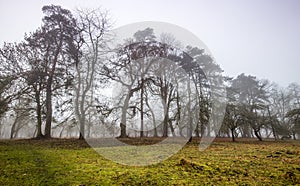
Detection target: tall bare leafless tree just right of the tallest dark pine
<box><xmin>74</xmin><ymin>9</ymin><xmax>110</xmax><ymax>139</ymax></box>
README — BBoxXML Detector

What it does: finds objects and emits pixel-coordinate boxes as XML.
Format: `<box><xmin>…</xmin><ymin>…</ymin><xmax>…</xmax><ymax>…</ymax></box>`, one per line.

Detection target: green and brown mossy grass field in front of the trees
<box><xmin>0</xmin><ymin>139</ymin><xmax>300</xmax><ymax>186</ymax></box>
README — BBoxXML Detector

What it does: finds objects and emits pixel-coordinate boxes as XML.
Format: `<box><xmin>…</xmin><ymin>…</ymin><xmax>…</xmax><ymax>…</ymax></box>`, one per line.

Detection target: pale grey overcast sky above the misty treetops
<box><xmin>0</xmin><ymin>0</ymin><xmax>300</xmax><ymax>86</ymax></box>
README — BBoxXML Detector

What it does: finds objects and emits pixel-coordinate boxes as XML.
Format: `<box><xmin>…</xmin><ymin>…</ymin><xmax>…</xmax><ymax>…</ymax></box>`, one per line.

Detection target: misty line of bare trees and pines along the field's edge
<box><xmin>0</xmin><ymin>5</ymin><xmax>300</xmax><ymax>141</ymax></box>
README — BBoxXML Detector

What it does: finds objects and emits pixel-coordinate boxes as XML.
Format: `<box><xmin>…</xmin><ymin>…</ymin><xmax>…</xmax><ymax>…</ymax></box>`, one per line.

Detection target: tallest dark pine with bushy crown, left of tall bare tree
<box><xmin>27</xmin><ymin>5</ymin><xmax>79</xmax><ymax>138</ymax></box>
